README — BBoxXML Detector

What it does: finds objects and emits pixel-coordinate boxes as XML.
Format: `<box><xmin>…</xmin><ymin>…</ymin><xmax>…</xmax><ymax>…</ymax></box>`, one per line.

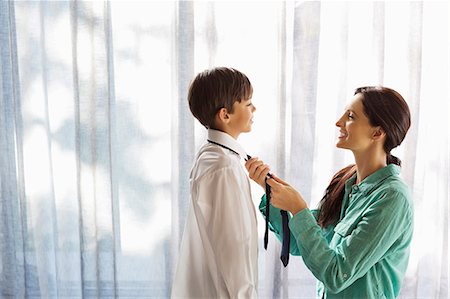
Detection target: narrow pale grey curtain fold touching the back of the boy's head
<box><xmin>170</xmin><ymin>1</ymin><xmax>195</xmax><ymax>296</ymax></box>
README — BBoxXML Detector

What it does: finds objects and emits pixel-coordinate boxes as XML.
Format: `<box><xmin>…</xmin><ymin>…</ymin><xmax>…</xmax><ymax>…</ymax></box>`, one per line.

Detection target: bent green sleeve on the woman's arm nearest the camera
<box><xmin>289</xmin><ymin>191</ymin><xmax>412</xmax><ymax>293</ymax></box>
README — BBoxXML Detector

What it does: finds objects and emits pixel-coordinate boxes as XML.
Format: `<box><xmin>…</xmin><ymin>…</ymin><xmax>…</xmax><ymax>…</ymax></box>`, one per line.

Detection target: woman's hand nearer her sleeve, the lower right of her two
<box><xmin>267</xmin><ymin>175</ymin><xmax>308</xmax><ymax>215</ymax></box>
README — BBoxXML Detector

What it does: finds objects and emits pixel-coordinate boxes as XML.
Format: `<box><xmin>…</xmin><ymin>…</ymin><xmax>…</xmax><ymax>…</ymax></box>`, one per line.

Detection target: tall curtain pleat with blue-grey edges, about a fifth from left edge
<box><xmin>72</xmin><ymin>2</ymin><xmax>116</xmax><ymax>297</ymax></box>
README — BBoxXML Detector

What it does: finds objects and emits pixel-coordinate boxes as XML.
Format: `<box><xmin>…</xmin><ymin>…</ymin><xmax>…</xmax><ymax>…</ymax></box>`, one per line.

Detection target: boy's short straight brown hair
<box><xmin>188</xmin><ymin>67</ymin><xmax>253</xmax><ymax>129</ymax></box>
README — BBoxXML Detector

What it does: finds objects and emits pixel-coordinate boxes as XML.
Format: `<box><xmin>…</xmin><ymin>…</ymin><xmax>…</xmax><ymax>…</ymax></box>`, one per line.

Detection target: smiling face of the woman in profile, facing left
<box><xmin>336</xmin><ymin>93</ymin><xmax>376</xmax><ymax>152</ymax></box>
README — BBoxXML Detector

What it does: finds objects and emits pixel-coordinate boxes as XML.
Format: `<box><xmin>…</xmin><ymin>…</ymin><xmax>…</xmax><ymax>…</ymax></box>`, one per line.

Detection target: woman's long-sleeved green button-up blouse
<box><xmin>259</xmin><ymin>164</ymin><xmax>413</xmax><ymax>299</ymax></box>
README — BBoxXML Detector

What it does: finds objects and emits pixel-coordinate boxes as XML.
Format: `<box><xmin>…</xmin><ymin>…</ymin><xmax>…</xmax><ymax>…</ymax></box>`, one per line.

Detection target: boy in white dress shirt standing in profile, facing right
<box><xmin>172</xmin><ymin>67</ymin><xmax>258</xmax><ymax>298</ymax></box>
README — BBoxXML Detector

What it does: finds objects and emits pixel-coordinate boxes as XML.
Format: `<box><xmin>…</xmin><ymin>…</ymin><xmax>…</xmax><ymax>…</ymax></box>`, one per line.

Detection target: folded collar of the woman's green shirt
<box><xmin>345</xmin><ymin>164</ymin><xmax>400</xmax><ymax>194</ymax></box>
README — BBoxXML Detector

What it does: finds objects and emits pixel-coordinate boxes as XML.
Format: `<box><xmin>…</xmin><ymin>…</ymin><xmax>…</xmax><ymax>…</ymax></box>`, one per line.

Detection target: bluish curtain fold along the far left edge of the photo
<box><xmin>0</xmin><ymin>1</ymin><xmax>28</xmax><ymax>297</ymax></box>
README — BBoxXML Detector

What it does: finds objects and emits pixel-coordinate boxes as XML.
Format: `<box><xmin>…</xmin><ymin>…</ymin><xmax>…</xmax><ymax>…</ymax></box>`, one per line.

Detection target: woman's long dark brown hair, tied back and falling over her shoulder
<box><xmin>318</xmin><ymin>86</ymin><xmax>411</xmax><ymax>227</ymax></box>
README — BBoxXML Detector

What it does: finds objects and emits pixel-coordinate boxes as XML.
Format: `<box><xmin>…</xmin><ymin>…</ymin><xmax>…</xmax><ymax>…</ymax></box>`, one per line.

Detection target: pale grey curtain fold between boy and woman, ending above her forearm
<box><xmin>290</xmin><ymin>2</ymin><xmax>321</xmax><ymax>206</ymax></box>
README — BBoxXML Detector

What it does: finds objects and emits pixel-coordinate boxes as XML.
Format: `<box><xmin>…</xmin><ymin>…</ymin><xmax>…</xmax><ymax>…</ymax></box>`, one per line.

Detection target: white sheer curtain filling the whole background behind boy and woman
<box><xmin>0</xmin><ymin>1</ymin><xmax>450</xmax><ymax>298</ymax></box>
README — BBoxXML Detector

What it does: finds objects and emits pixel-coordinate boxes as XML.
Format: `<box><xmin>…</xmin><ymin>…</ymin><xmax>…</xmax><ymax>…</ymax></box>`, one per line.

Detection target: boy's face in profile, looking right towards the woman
<box><xmin>227</xmin><ymin>98</ymin><xmax>256</xmax><ymax>139</ymax></box>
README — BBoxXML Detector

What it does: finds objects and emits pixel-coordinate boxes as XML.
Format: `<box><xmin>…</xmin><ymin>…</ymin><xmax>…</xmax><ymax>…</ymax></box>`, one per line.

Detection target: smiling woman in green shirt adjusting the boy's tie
<box><xmin>246</xmin><ymin>87</ymin><xmax>413</xmax><ymax>298</ymax></box>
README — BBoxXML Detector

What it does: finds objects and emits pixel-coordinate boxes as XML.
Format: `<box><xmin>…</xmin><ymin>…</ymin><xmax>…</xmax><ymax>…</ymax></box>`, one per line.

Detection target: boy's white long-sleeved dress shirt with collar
<box><xmin>171</xmin><ymin>129</ymin><xmax>258</xmax><ymax>298</ymax></box>
